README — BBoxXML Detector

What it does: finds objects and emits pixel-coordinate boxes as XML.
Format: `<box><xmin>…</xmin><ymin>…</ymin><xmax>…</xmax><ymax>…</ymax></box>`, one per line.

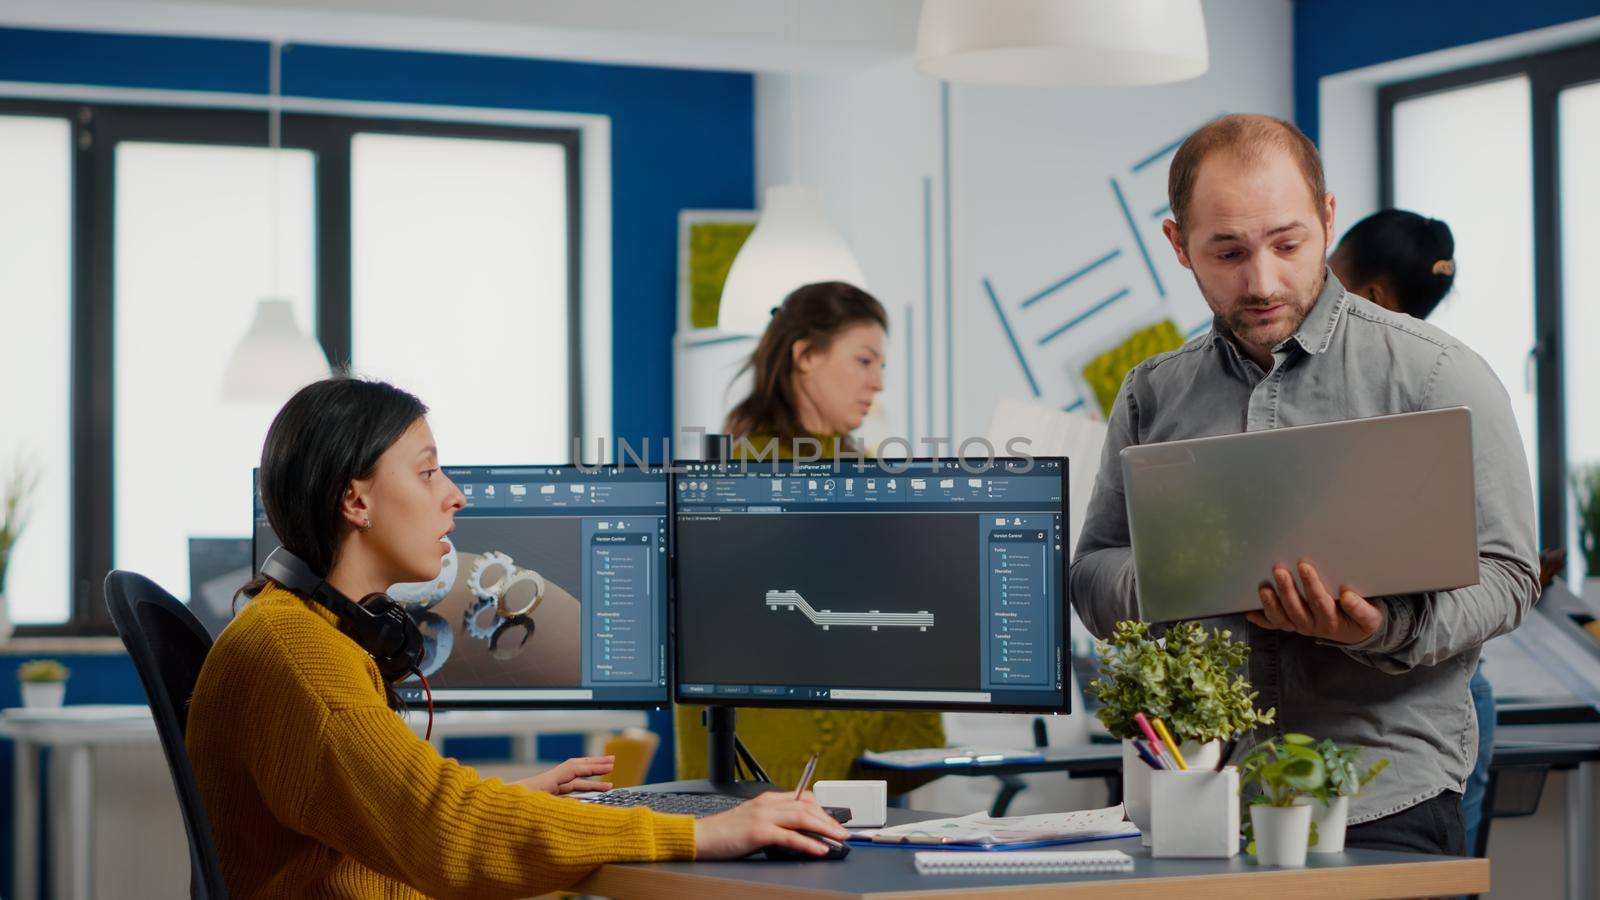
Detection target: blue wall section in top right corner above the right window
<box><xmin>1294</xmin><ymin>0</ymin><xmax>1600</xmax><ymax>141</ymax></box>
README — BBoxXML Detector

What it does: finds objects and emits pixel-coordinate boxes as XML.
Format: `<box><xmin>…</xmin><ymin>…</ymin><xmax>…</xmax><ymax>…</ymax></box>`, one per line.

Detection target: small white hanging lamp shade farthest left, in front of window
<box><xmin>222</xmin><ymin>299</ymin><xmax>330</xmax><ymax>404</ymax></box>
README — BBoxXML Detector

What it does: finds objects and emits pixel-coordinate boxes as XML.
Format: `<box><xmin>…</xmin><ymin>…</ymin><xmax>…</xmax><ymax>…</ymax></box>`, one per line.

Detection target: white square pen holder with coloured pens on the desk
<box><xmin>1150</xmin><ymin>765</ymin><xmax>1238</xmax><ymax>858</ymax></box>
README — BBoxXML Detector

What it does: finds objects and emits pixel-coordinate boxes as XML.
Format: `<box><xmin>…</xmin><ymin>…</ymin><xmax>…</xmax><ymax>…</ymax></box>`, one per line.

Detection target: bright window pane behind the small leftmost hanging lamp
<box><xmin>112</xmin><ymin>141</ymin><xmax>315</xmax><ymax>597</ymax></box>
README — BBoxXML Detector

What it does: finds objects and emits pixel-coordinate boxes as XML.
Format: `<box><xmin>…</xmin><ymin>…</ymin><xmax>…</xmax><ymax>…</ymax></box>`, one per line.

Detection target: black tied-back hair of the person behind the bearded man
<box><xmin>1334</xmin><ymin>210</ymin><xmax>1456</xmax><ymax>319</ymax></box>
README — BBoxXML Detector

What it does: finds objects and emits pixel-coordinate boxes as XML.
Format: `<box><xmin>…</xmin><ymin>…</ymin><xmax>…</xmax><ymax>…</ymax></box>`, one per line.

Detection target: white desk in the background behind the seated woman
<box><xmin>0</xmin><ymin>706</ymin><xmax>646</xmax><ymax>900</ymax></box>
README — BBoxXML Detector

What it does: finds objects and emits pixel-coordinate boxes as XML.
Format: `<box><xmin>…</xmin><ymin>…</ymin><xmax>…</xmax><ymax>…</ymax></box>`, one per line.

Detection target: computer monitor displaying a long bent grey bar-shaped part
<box><xmin>672</xmin><ymin>458</ymin><xmax>1070</xmax><ymax>713</ymax></box>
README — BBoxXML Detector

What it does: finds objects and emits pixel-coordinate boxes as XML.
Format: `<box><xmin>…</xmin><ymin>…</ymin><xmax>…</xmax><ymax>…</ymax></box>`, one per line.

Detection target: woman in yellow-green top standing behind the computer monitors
<box><xmin>675</xmin><ymin>282</ymin><xmax>944</xmax><ymax>793</ymax></box>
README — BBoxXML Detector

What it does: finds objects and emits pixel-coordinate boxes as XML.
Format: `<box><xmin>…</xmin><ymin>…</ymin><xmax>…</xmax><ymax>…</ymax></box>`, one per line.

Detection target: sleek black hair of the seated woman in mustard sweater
<box><xmin>235</xmin><ymin>375</ymin><xmax>427</xmax><ymax>706</ymax></box>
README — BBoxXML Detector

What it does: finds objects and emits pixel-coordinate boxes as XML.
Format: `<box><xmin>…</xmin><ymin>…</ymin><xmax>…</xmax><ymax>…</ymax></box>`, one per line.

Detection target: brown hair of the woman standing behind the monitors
<box><xmin>723</xmin><ymin>282</ymin><xmax>890</xmax><ymax>442</ymax></box>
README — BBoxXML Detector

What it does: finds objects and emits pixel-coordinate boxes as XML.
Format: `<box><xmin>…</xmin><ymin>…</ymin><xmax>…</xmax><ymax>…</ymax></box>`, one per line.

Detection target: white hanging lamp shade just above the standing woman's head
<box><xmin>717</xmin><ymin>184</ymin><xmax>867</xmax><ymax>335</ymax></box>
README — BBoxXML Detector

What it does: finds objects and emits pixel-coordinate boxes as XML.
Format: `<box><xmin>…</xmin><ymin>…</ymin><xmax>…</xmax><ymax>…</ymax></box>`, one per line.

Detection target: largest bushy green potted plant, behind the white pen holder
<box><xmin>1088</xmin><ymin>620</ymin><xmax>1274</xmax><ymax>844</ymax></box>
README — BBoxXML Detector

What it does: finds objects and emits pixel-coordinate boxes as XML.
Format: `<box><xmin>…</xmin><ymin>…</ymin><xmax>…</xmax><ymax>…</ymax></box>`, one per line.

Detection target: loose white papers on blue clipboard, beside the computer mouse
<box><xmin>850</xmin><ymin>804</ymin><xmax>1139</xmax><ymax>850</ymax></box>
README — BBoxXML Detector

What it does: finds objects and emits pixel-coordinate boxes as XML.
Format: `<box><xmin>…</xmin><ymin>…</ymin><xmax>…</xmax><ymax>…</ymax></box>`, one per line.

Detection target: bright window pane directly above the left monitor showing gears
<box><xmin>350</xmin><ymin>133</ymin><xmax>574</xmax><ymax>464</ymax></box>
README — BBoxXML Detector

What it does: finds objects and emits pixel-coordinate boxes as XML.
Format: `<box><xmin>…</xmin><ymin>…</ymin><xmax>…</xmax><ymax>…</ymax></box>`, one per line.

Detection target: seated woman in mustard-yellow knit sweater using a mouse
<box><xmin>187</xmin><ymin>378</ymin><xmax>846</xmax><ymax>898</ymax></box>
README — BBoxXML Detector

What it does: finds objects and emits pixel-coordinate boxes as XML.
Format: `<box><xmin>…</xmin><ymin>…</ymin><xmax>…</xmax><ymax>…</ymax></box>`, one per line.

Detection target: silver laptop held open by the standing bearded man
<box><xmin>1122</xmin><ymin>407</ymin><xmax>1478</xmax><ymax>621</ymax></box>
